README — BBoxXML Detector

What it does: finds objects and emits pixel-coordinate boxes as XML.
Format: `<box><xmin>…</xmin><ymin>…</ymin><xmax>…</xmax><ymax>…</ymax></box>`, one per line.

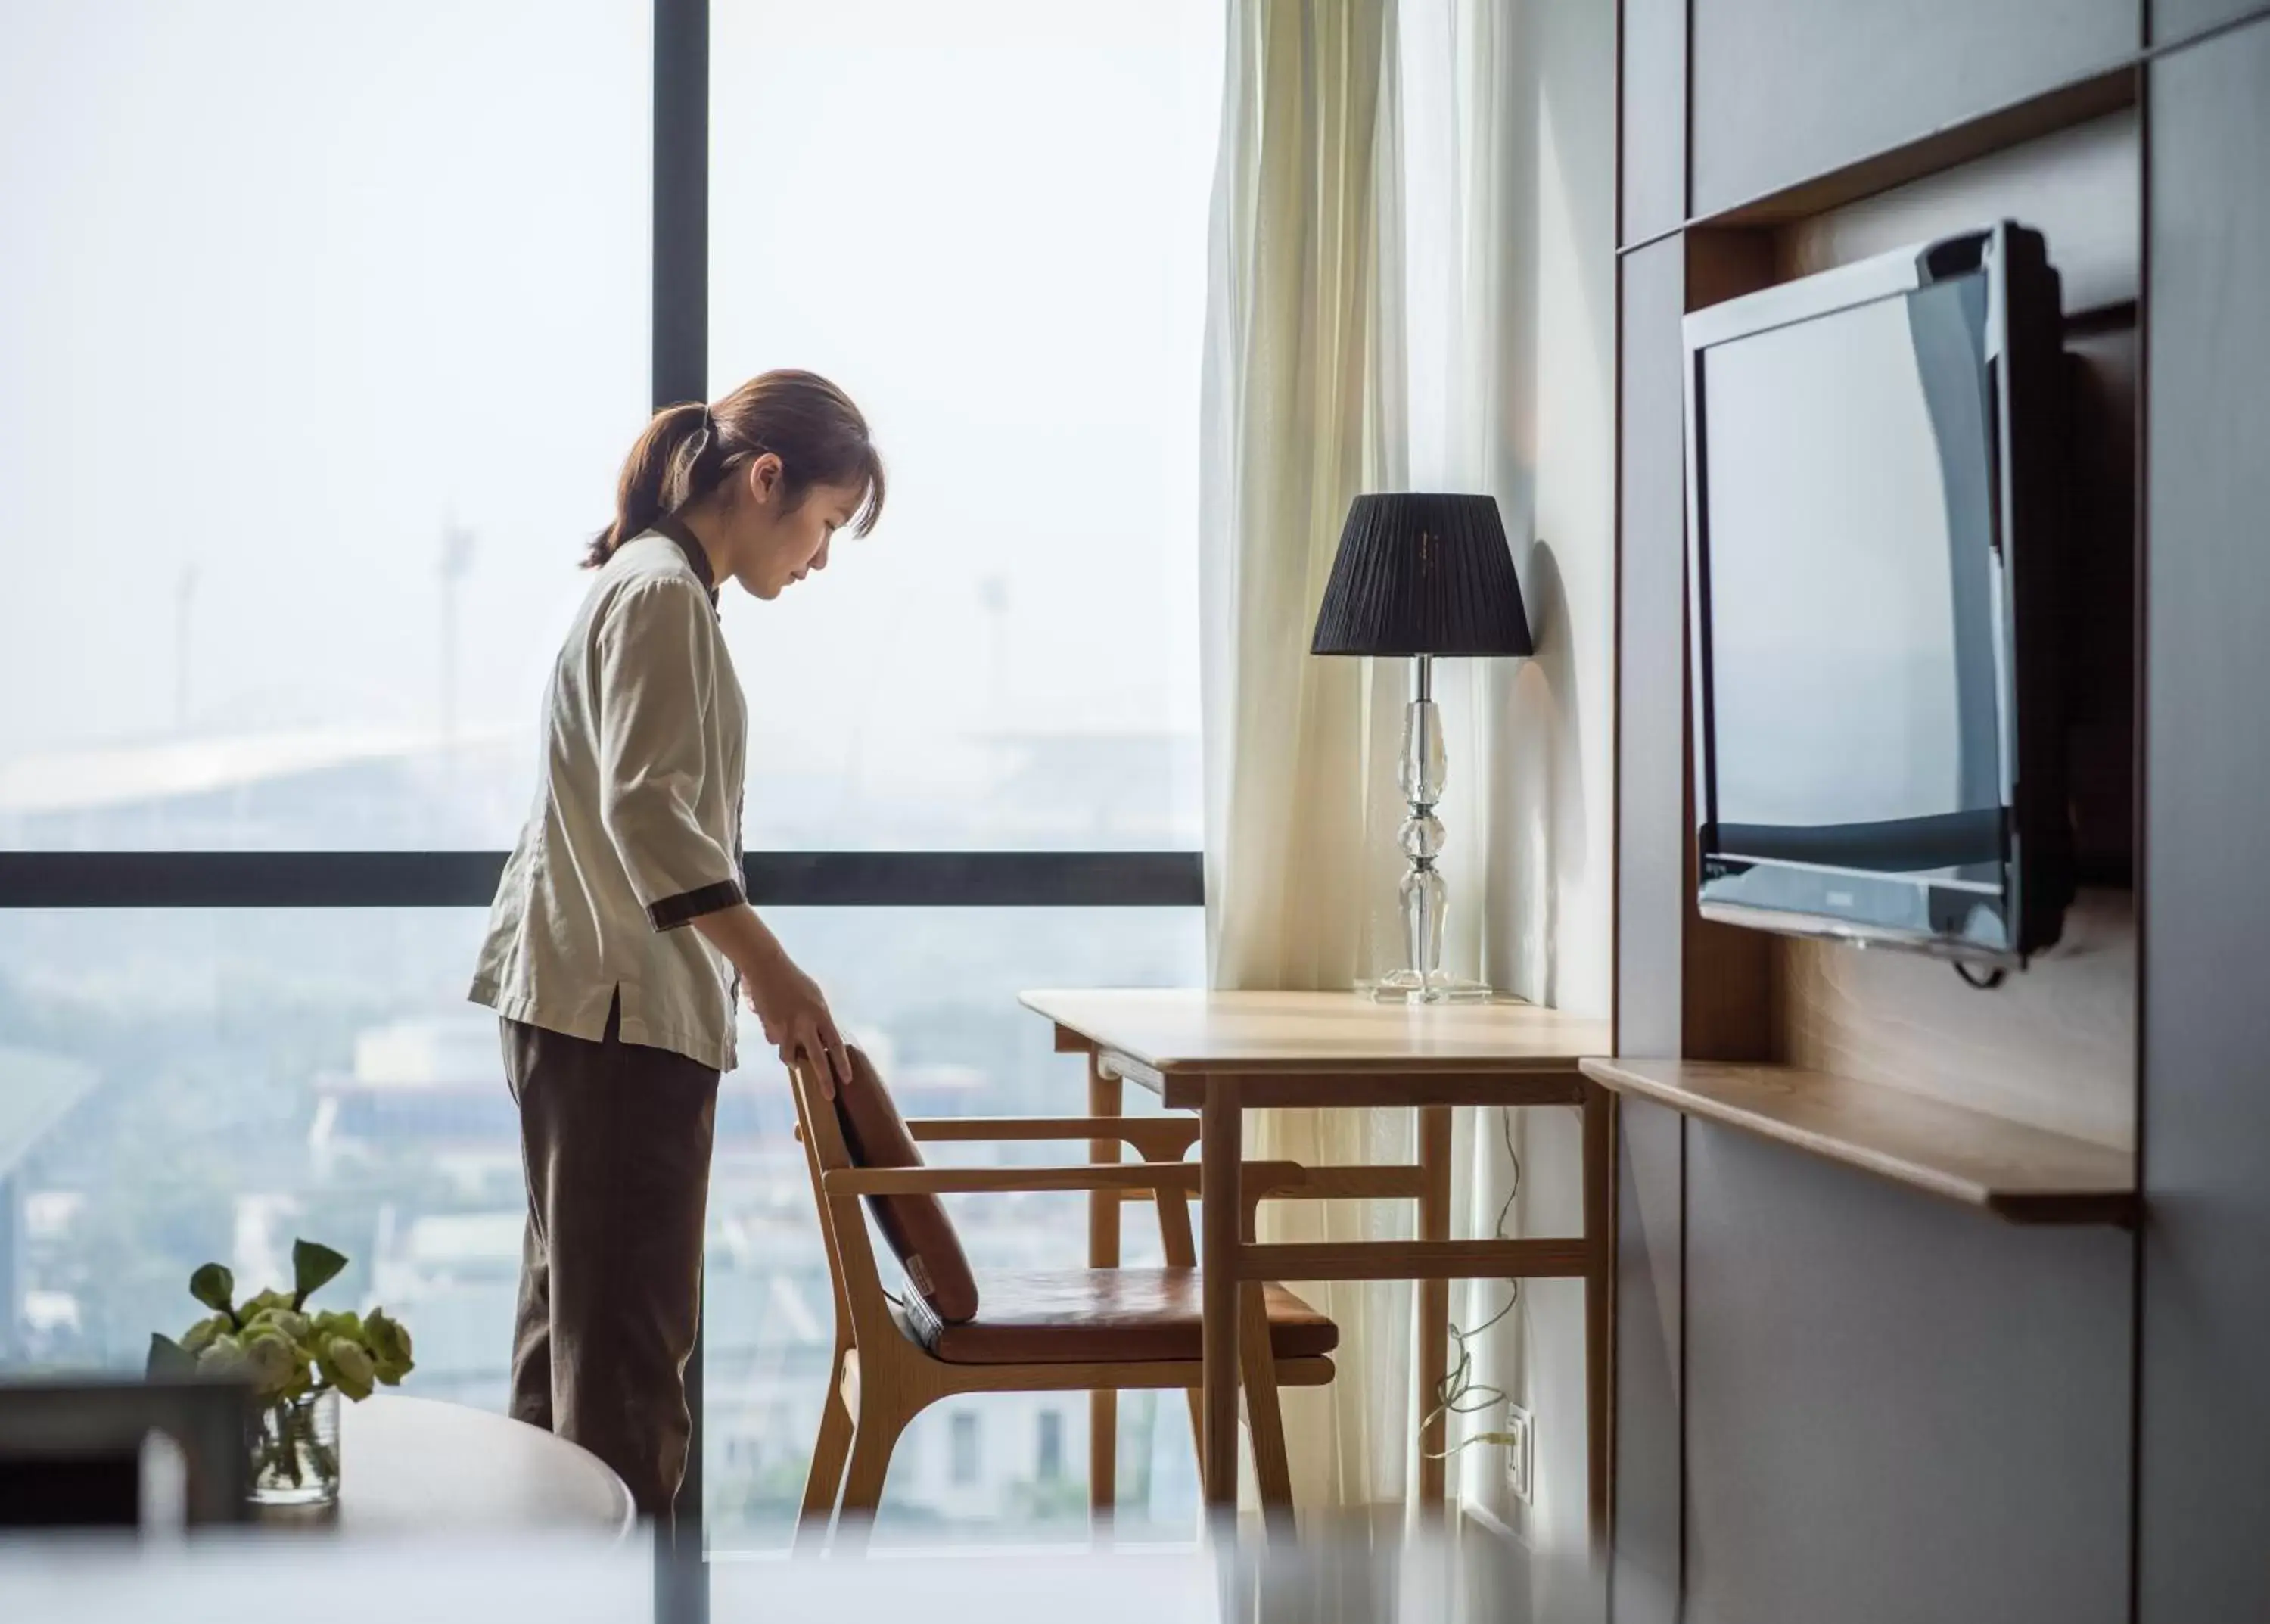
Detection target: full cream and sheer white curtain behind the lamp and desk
<box><xmin>1201</xmin><ymin>0</ymin><xmax>1503</xmax><ymax>1506</ymax></box>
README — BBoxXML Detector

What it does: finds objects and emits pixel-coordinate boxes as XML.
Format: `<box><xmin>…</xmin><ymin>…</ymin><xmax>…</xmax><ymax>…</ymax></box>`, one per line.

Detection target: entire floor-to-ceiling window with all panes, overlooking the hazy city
<box><xmin>0</xmin><ymin>0</ymin><xmax>1221</xmax><ymax>1551</ymax></box>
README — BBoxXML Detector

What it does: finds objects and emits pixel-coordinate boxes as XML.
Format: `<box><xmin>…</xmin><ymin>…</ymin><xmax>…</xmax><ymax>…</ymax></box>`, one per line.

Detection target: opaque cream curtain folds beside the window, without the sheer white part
<box><xmin>1199</xmin><ymin>0</ymin><xmax>1412</xmax><ymax>1506</ymax></box>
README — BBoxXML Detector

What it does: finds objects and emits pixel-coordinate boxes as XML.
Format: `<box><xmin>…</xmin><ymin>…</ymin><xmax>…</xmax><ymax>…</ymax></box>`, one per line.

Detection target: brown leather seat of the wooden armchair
<box><xmin>908</xmin><ymin>1270</ymin><xmax>1339</xmax><ymax>1365</ymax></box>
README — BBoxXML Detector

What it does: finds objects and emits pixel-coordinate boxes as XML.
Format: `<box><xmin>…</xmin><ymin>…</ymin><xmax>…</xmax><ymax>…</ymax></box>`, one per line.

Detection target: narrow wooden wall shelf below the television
<box><xmin>1582</xmin><ymin>1059</ymin><xmax>2136</xmax><ymax>1224</ymax></box>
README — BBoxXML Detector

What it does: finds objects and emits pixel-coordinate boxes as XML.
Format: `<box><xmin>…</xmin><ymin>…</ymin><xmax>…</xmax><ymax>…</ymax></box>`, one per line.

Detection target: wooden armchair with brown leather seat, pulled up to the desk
<box><xmin>790</xmin><ymin>1066</ymin><xmax>1419</xmax><ymax>1549</ymax></box>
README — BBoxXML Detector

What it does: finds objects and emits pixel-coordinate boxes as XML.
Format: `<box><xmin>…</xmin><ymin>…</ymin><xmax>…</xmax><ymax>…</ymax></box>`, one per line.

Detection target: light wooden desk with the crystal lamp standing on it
<box><xmin>1024</xmin><ymin>991</ymin><xmax>1616</xmax><ymax>1540</ymax></box>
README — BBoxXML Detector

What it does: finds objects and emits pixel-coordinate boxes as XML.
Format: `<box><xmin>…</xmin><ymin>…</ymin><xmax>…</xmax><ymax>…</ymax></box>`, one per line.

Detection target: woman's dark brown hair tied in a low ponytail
<box><xmin>583</xmin><ymin>370</ymin><xmax>883</xmax><ymax>570</ymax></box>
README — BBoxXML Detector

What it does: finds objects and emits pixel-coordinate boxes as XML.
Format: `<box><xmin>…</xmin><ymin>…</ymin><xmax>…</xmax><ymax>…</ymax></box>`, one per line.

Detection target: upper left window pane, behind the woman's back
<box><xmin>0</xmin><ymin>0</ymin><xmax>651</xmax><ymax>850</ymax></box>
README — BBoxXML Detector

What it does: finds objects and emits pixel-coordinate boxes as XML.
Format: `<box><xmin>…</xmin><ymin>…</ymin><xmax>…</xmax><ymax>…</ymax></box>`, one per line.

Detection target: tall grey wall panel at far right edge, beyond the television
<box><xmin>2138</xmin><ymin>23</ymin><xmax>2270</xmax><ymax>1624</ymax></box>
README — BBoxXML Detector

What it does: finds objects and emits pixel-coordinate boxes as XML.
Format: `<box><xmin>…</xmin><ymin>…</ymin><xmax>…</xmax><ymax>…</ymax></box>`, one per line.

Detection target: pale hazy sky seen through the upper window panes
<box><xmin>0</xmin><ymin>0</ymin><xmax>1221</xmax><ymax>817</ymax></box>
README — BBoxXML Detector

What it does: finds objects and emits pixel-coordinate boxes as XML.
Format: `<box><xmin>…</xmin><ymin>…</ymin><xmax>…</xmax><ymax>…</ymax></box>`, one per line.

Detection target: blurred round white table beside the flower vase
<box><xmin>306</xmin><ymin>1392</ymin><xmax>636</xmax><ymax>1540</ymax></box>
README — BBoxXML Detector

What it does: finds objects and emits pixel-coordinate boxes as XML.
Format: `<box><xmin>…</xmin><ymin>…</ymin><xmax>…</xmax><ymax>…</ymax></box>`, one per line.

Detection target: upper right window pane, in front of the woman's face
<box><xmin>708</xmin><ymin>0</ymin><xmax>1221</xmax><ymax>848</ymax></box>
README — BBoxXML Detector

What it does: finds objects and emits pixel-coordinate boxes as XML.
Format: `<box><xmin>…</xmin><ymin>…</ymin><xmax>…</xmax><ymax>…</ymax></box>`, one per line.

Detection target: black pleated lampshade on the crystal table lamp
<box><xmin>1308</xmin><ymin>490</ymin><xmax>1535</xmax><ymax>656</ymax></box>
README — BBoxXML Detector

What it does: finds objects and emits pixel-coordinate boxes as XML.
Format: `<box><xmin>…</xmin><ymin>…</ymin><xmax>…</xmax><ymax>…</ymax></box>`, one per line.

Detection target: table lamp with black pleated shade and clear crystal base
<box><xmin>1308</xmin><ymin>490</ymin><xmax>1535</xmax><ymax>1004</ymax></box>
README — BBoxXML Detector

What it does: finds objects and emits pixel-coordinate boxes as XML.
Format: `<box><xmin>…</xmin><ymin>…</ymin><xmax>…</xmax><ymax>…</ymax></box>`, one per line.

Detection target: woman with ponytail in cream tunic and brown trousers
<box><xmin>472</xmin><ymin>372</ymin><xmax>883</xmax><ymax>1517</ymax></box>
